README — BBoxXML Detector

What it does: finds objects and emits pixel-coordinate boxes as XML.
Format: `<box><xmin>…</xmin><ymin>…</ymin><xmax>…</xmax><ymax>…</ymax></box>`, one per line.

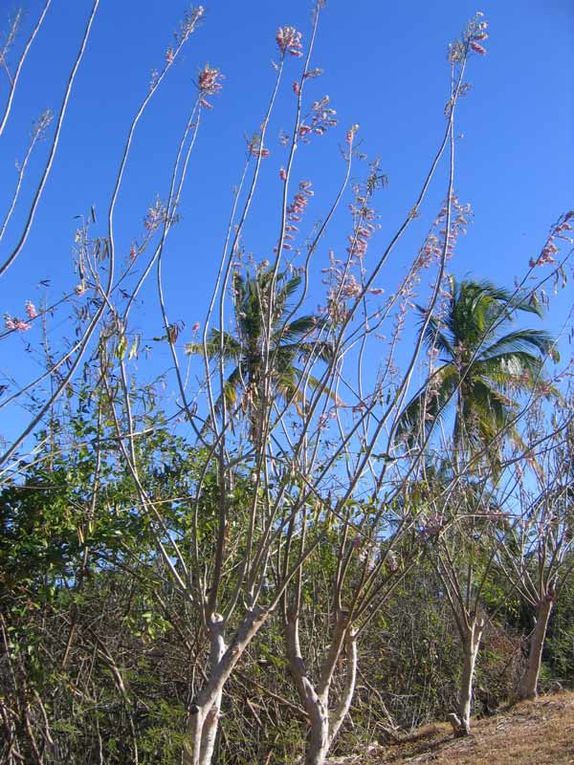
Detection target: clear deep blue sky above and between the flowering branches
<box><xmin>0</xmin><ymin>0</ymin><xmax>574</xmax><ymax>442</ymax></box>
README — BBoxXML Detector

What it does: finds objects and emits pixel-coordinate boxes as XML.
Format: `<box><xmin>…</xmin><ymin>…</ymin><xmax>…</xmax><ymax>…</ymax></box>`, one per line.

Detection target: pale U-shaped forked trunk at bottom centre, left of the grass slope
<box><xmin>285</xmin><ymin>614</ymin><xmax>357</xmax><ymax>765</ymax></box>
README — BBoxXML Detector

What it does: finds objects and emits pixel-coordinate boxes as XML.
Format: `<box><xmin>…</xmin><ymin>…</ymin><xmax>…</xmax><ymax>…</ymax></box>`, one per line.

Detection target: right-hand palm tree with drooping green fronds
<box><xmin>398</xmin><ymin>277</ymin><xmax>558</xmax><ymax>466</ymax></box>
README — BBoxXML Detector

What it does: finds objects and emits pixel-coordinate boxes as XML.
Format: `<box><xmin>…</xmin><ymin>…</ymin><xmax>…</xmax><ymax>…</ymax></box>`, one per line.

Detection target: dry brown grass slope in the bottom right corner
<box><xmin>330</xmin><ymin>693</ymin><xmax>574</xmax><ymax>765</ymax></box>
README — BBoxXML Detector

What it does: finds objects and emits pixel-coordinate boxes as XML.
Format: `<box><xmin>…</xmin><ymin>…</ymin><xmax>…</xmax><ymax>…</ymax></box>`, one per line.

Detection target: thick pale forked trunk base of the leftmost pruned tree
<box><xmin>182</xmin><ymin>609</ymin><xmax>269</xmax><ymax>765</ymax></box>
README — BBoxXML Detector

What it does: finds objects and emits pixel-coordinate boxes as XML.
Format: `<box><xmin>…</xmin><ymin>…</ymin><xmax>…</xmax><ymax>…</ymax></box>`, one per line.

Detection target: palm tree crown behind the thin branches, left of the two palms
<box><xmin>186</xmin><ymin>267</ymin><xmax>333</xmax><ymax>443</ymax></box>
